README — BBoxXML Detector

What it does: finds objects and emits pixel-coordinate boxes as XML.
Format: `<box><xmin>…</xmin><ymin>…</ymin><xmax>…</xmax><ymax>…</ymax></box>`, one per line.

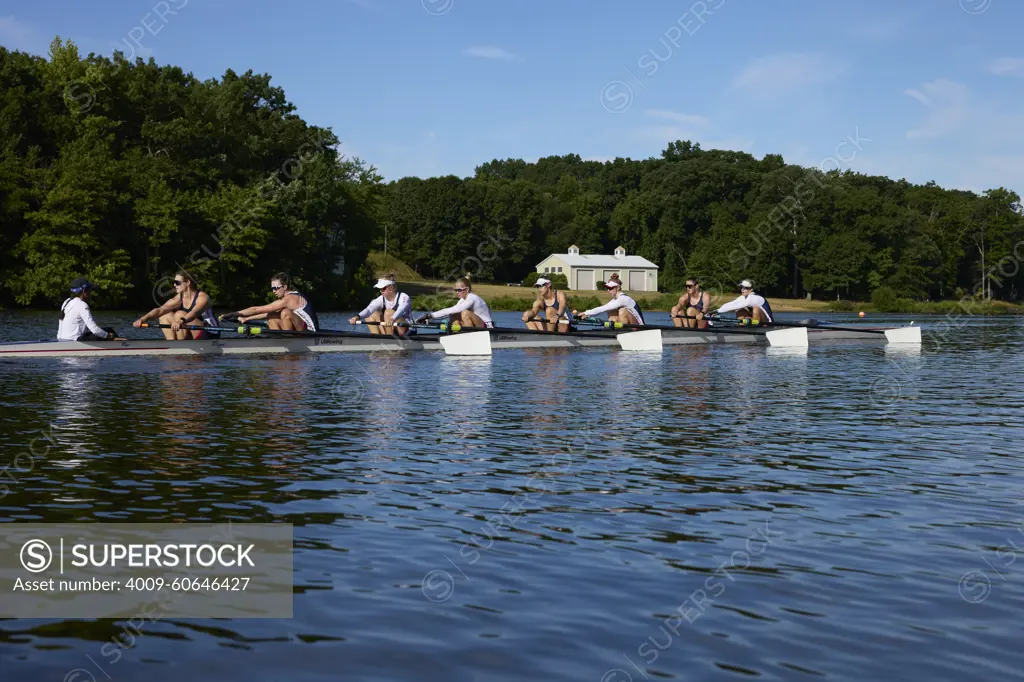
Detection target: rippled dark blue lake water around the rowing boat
<box><xmin>0</xmin><ymin>313</ymin><xmax>1024</xmax><ymax>682</ymax></box>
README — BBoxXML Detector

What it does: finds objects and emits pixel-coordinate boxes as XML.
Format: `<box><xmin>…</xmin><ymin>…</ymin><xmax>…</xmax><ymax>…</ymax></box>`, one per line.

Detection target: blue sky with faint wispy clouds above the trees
<box><xmin>0</xmin><ymin>0</ymin><xmax>1024</xmax><ymax>193</ymax></box>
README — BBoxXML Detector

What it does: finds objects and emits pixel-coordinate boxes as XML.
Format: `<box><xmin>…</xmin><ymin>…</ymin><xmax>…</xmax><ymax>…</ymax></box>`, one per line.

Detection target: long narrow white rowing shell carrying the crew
<box><xmin>0</xmin><ymin>321</ymin><xmax>917</xmax><ymax>357</ymax></box>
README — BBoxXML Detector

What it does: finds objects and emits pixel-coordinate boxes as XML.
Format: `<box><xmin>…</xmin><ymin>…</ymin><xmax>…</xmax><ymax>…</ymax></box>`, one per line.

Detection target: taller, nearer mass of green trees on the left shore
<box><xmin>0</xmin><ymin>38</ymin><xmax>383</xmax><ymax>308</ymax></box>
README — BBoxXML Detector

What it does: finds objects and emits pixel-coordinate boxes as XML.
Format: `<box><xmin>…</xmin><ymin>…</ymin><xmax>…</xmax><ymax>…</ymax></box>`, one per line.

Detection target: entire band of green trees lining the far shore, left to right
<box><xmin>0</xmin><ymin>39</ymin><xmax>1024</xmax><ymax>308</ymax></box>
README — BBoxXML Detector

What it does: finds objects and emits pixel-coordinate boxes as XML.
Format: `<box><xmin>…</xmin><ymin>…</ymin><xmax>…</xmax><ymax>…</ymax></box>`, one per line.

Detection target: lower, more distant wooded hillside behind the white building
<box><xmin>383</xmin><ymin>141</ymin><xmax>1024</xmax><ymax>300</ymax></box>
